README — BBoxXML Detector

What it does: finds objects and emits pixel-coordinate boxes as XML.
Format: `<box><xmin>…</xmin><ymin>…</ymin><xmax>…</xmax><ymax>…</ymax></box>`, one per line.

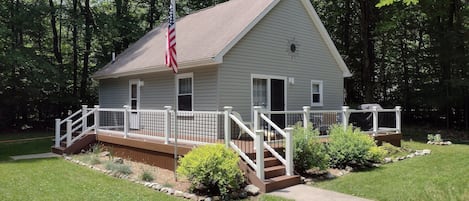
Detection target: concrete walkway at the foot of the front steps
<box><xmin>267</xmin><ymin>184</ymin><xmax>371</xmax><ymax>201</ymax></box>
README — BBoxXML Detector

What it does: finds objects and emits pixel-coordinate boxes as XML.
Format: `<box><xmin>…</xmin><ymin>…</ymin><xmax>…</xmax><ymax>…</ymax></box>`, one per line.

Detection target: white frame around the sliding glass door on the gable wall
<box><xmin>249</xmin><ymin>74</ymin><xmax>288</xmax><ymax>121</ymax></box>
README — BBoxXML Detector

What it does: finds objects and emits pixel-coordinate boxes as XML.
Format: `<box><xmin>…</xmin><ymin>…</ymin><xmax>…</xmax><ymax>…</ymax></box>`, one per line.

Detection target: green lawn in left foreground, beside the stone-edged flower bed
<box><xmin>0</xmin><ymin>159</ymin><xmax>182</xmax><ymax>200</ymax></box>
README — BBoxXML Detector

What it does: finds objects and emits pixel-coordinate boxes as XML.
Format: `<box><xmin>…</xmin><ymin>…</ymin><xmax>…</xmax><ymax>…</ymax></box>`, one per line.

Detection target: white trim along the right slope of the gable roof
<box><xmin>301</xmin><ymin>0</ymin><xmax>352</xmax><ymax>77</ymax></box>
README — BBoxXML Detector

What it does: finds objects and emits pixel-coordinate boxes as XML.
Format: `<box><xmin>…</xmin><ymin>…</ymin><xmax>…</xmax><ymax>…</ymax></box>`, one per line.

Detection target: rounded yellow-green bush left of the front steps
<box><xmin>177</xmin><ymin>144</ymin><xmax>244</xmax><ymax>197</ymax></box>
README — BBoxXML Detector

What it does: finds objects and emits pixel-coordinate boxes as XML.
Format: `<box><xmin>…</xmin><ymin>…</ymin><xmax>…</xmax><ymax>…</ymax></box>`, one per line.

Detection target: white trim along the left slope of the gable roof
<box><xmin>213</xmin><ymin>0</ymin><xmax>280</xmax><ymax>63</ymax></box>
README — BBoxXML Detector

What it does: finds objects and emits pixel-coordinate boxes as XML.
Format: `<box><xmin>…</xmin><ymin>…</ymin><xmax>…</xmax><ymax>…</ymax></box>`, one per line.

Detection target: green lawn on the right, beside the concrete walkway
<box><xmin>315</xmin><ymin>142</ymin><xmax>469</xmax><ymax>201</ymax></box>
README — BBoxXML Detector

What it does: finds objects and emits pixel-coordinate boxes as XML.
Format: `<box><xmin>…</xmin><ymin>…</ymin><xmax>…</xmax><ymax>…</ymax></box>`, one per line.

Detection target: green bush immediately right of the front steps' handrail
<box><xmin>293</xmin><ymin>124</ymin><xmax>329</xmax><ymax>174</ymax></box>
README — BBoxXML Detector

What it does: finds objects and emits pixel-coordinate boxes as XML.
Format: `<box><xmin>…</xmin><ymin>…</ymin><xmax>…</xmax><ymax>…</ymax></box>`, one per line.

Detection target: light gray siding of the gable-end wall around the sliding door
<box><xmin>219</xmin><ymin>0</ymin><xmax>343</xmax><ymax>119</ymax></box>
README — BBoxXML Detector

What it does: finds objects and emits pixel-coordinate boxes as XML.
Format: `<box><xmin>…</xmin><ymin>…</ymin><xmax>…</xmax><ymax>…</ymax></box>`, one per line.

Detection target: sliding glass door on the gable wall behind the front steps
<box><xmin>252</xmin><ymin>76</ymin><xmax>285</xmax><ymax>128</ymax></box>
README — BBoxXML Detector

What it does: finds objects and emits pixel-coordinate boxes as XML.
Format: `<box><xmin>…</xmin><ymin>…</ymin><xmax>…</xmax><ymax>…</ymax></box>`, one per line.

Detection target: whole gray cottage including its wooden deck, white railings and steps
<box><xmin>53</xmin><ymin>0</ymin><xmax>400</xmax><ymax>192</ymax></box>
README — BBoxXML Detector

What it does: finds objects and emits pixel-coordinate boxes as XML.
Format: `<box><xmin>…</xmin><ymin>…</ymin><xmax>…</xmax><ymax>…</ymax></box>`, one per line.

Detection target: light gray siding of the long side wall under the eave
<box><xmin>99</xmin><ymin>66</ymin><xmax>217</xmax><ymax>111</ymax></box>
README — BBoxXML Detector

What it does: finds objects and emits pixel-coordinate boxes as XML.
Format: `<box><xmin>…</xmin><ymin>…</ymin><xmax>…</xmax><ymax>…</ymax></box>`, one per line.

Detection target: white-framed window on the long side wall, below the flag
<box><xmin>176</xmin><ymin>73</ymin><xmax>194</xmax><ymax>111</ymax></box>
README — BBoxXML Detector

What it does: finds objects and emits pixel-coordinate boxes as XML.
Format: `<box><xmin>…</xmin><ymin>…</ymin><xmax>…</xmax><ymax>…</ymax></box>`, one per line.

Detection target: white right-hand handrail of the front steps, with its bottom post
<box><xmin>259</xmin><ymin>112</ymin><xmax>293</xmax><ymax>176</ymax></box>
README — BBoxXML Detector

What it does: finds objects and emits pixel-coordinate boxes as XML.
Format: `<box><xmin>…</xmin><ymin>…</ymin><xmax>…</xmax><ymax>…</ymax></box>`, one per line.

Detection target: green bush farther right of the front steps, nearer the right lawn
<box><xmin>327</xmin><ymin>125</ymin><xmax>385</xmax><ymax>168</ymax></box>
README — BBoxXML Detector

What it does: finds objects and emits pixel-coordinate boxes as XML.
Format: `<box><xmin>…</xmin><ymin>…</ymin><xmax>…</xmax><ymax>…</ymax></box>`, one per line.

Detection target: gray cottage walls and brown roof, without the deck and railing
<box><xmin>93</xmin><ymin>0</ymin><xmax>351</xmax><ymax>122</ymax></box>
